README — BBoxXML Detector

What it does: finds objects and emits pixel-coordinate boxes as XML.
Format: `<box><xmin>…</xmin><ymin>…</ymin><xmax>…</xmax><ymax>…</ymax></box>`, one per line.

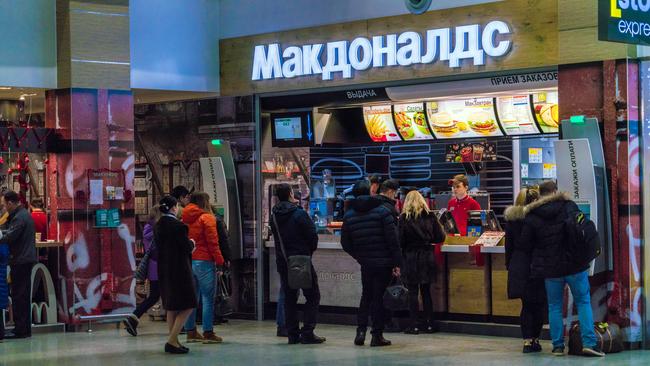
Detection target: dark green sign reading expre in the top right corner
<box><xmin>598</xmin><ymin>0</ymin><xmax>650</xmax><ymax>45</ymax></box>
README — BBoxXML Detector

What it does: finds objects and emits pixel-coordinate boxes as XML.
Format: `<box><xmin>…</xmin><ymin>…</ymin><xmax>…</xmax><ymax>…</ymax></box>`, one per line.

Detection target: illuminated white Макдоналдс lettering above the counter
<box><xmin>251</xmin><ymin>20</ymin><xmax>512</xmax><ymax>80</ymax></box>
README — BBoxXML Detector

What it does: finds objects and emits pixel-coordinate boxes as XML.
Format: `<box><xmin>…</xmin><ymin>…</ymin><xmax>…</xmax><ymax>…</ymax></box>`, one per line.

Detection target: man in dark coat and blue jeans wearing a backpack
<box><xmin>520</xmin><ymin>181</ymin><xmax>605</xmax><ymax>357</ymax></box>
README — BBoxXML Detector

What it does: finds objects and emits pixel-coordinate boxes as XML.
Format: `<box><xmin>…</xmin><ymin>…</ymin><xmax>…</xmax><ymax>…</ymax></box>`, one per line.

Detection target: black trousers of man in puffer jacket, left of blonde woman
<box><xmin>357</xmin><ymin>266</ymin><xmax>393</xmax><ymax>334</ymax></box>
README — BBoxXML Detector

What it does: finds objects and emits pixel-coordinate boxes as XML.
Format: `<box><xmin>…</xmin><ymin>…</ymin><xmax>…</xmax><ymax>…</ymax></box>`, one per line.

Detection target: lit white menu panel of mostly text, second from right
<box><xmin>497</xmin><ymin>95</ymin><xmax>540</xmax><ymax>135</ymax></box>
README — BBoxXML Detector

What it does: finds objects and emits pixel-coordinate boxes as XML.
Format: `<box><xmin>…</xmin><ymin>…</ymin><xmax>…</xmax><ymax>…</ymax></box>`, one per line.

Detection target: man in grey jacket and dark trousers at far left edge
<box><xmin>0</xmin><ymin>191</ymin><xmax>36</xmax><ymax>338</ymax></box>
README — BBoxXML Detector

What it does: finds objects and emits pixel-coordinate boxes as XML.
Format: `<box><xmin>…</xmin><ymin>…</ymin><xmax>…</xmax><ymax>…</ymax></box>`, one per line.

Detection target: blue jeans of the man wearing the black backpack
<box><xmin>545</xmin><ymin>270</ymin><xmax>597</xmax><ymax>348</ymax></box>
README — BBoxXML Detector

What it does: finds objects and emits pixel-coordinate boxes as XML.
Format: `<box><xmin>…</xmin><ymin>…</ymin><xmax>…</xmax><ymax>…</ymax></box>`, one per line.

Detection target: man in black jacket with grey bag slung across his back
<box><xmin>271</xmin><ymin>184</ymin><xmax>325</xmax><ymax>344</ymax></box>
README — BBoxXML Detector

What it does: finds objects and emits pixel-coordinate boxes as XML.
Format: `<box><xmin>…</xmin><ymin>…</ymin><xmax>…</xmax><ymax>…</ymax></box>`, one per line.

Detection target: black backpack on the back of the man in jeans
<box><xmin>564</xmin><ymin>202</ymin><xmax>601</xmax><ymax>267</ymax></box>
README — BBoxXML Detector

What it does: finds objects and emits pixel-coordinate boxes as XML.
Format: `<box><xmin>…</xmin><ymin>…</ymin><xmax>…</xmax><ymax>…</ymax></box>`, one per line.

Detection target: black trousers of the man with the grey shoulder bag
<box><xmin>278</xmin><ymin>266</ymin><xmax>320</xmax><ymax>337</ymax></box>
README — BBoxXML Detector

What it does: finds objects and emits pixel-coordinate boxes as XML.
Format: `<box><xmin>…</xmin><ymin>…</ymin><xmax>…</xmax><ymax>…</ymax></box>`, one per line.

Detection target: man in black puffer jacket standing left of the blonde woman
<box><xmin>341</xmin><ymin>181</ymin><xmax>402</xmax><ymax>346</ymax></box>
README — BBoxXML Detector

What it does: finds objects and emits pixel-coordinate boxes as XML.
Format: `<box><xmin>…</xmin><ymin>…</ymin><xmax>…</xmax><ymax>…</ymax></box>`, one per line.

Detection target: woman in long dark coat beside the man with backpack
<box><xmin>504</xmin><ymin>187</ymin><xmax>547</xmax><ymax>353</ymax></box>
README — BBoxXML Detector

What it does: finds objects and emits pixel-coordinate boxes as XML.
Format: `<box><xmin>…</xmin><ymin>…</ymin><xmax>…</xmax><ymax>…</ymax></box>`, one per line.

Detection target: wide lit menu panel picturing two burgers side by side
<box><xmin>426</xmin><ymin>98</ymin><xmax>503</xmax><ymax>139</ymax></box>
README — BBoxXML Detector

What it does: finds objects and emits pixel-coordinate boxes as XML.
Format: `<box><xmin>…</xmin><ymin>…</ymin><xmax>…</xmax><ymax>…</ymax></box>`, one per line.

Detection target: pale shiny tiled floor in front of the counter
<box><xmin>0</xmin><ymin>321</ymin><xmax>650</xmax><ymax>366</ymax></box>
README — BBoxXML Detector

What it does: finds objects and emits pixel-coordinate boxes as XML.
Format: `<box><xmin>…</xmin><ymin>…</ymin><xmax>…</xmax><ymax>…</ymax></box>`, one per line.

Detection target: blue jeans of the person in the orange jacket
<box><xmin>185</xmin><ymin>261</ymin><xmax>217</xmax><ymax>332</ymax></box>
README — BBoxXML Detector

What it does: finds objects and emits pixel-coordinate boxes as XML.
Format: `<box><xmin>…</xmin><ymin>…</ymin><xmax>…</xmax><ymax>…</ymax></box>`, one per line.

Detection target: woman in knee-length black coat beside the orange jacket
<box><xmin>154</xmin><ymin>196</ymin><xmax>196</xmax><ymax>354</ymax></box>
